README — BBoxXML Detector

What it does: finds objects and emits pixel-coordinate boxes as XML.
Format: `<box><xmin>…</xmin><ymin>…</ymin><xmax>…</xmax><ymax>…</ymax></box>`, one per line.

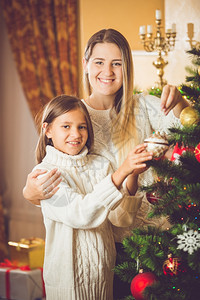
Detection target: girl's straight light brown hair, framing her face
<box><xmin>35</xmin><ymin>95</ymin><xmax>94</xmax><ymax>163</ymax></box>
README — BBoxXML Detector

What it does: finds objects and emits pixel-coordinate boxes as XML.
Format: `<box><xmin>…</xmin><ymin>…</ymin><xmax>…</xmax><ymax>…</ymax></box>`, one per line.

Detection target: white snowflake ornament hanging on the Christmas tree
<box><xmin>177</xmin><ymin>229</ymin><xmax>200</xmax><ymax>254</ymax></box>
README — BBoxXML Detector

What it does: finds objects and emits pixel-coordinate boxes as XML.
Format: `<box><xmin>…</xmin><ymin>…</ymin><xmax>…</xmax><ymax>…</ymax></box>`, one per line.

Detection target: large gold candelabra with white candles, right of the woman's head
<box><xmin>140</xmin><ymin>10</ymin><xmax>176</xmax><ymax>88</ymax></box>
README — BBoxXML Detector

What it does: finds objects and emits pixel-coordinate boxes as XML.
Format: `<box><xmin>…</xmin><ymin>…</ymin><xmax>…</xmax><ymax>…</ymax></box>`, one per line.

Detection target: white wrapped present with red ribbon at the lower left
<box><xmin>0</xmin><ymin>260</ymin><xmax>45</xmax><ymax>300</ymax></box>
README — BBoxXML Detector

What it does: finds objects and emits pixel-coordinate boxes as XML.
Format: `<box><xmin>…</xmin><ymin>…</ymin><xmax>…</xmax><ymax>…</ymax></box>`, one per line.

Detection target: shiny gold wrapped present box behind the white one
<box><xmin>8</xmin><ymin>238</ymin><xmax>45</xmax><ymax>269</ymax></box>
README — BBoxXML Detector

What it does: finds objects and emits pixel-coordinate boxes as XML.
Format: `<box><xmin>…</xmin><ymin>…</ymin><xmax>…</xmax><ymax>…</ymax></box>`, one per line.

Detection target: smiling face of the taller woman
<box><xmin>83</xmin><ymin>43</ymin><xmax>123</xmax><ymax>96</ymax></box>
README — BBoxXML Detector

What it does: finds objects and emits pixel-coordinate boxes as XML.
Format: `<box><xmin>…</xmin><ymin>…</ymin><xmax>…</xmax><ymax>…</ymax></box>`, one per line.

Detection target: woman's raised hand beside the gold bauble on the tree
<box><xmin>161</xmin><ymin>84</ymin><xmax>189</xmax><ymax>118</ymax></box>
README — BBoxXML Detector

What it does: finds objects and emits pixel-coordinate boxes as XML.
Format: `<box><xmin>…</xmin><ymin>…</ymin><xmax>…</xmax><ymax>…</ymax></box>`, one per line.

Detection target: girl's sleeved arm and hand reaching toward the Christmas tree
<box><xmin>41</xmin><ymin>144</ymin><xmax>152</xmax><ymax>229</ymax></box>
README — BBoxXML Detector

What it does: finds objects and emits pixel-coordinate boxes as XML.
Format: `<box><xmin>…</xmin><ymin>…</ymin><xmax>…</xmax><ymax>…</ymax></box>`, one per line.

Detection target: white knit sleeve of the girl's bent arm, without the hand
<box><xmin>41</xmin><ymin>175</ymin><xmax>122</xmax><ymax>229</ymax></box>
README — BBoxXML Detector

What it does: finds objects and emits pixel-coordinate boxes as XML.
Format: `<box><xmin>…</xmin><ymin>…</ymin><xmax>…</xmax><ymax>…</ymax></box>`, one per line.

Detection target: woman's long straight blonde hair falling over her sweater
<box><xmin>84</xmin><ymin>29</ymin><xmax>138</xmax><ymax>162</ymax></box>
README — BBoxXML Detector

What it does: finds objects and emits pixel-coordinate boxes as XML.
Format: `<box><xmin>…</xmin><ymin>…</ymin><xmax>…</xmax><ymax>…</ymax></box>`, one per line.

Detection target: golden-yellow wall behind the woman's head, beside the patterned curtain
<box><xmin>79</xmin><ymin>0</ymin><xmax>165</xmax><ymax>96</ymax></box>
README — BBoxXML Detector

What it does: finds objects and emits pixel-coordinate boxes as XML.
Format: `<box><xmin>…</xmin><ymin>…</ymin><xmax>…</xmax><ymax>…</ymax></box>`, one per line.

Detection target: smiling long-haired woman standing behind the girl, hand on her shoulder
<box><xmin>23</xmin><ymin>29</ymin><xmax>188</xmax><ymax>297</ymax></box>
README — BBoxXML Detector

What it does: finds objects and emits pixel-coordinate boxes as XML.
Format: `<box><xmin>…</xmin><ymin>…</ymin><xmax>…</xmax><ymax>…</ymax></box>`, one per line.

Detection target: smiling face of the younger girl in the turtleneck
<box><xmin>46</xmin><ymin>109</ymin><xmax>88</xmax><ymax>155</ymax></box>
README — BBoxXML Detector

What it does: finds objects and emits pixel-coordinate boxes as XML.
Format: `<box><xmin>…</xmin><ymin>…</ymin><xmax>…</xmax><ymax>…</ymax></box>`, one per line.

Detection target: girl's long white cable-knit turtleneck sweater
<box><xmin>34</xmin><ymin>146</ymin><xmax>141</xmax><ymax>300</ymax></box>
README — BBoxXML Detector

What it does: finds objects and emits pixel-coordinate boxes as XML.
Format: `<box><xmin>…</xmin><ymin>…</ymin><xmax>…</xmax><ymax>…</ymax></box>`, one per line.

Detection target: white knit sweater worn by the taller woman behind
<box><xmin>83</xmin><ymin>94</ymin><xmax>180</xmax><ymax>234</ymax></box>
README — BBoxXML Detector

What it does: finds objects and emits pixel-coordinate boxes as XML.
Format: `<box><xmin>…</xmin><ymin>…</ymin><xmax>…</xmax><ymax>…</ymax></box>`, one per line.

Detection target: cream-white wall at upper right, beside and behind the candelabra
<box><xmin>165</xmin><ymin>0</ymin><xmax>200</xmax><ymax>85</ymax></box>
